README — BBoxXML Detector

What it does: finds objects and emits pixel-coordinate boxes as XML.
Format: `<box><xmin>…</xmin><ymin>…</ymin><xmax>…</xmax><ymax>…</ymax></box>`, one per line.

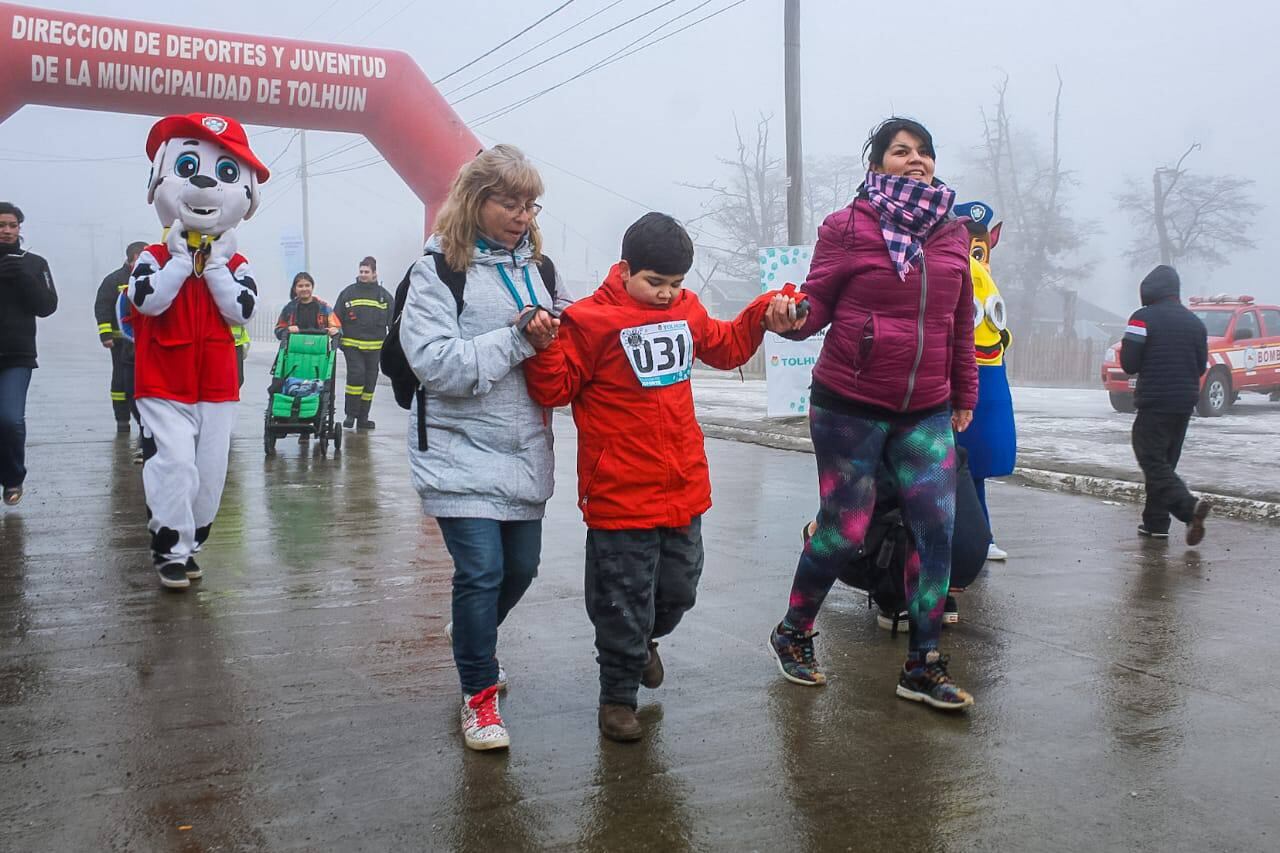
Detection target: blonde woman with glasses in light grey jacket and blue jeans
<box><xmin>401</xmin><ymin>145</ymin><xmax>568</xmax><ymax>749</ymax></box>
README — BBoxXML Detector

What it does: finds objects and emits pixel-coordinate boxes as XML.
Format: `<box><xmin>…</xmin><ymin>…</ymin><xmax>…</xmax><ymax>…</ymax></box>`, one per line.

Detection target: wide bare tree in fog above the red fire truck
<box><xmin>1116</xmin><ymin>142</ymin><xmax>1262</xmax><ymax>266</ymax></box>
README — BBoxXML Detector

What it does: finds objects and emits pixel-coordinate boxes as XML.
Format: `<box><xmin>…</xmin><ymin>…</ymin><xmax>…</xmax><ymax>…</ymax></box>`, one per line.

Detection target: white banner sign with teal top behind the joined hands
<box><xmin>760</xmin><ymin>246</ymin><xmax>827</xmax><ymax>418</ymax></box>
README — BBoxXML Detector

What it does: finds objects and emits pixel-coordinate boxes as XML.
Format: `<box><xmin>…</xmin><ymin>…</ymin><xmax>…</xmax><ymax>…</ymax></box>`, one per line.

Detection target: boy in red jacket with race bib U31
<box><xmin>524</xmin><ymin>213</ymin><xmax>800</xmax><ymax>740</ymax></box>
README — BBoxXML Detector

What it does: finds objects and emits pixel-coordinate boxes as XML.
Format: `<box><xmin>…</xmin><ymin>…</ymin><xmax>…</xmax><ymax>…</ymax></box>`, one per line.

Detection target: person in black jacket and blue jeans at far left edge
<box><xmin>0</xmin><ymin>201</ymin><xmax>58</xmax><ymax>506</ymax></box>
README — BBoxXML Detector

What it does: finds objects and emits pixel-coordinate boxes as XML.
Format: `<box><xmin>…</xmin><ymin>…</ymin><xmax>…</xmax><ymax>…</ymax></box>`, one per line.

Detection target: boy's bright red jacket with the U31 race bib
<box><xmin>524</xmin><ymin>265</ymin><xmax>773</xmax><ymax>530</ymax></box>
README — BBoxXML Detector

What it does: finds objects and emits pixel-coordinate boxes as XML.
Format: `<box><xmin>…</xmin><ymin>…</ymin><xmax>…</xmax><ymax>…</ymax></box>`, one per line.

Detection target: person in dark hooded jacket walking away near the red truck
<box><xmin>1120</xmin><ymin>264</ymin><xmax>1212</xmax><ymax>546</ymax></box>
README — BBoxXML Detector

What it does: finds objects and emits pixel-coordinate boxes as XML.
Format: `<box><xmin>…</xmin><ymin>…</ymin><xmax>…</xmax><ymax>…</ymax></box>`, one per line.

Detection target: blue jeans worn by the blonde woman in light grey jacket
<box><xmin>436</xmin><ymin>519</ymin><xmax>543</xmax><ymax>695</ymax></box>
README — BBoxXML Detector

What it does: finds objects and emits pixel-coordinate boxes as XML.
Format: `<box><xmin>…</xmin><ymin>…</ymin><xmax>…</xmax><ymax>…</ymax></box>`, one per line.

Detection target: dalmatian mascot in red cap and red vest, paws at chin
<box><xmin>122</xmin><ymin>113</ymin><xmax>270</xmax><ymax>589</ymax></box>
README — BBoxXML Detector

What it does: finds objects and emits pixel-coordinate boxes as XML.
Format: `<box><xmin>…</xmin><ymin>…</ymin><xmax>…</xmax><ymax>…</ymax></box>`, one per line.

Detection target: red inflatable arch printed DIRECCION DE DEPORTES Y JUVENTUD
<box><xmin>0</xmin><ymin>3</ymin><xmax>481</xmax><ymax>223</ymax></box>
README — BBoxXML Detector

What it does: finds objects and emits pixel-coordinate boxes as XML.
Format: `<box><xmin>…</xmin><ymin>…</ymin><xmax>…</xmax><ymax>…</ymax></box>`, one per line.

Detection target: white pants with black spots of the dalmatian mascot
<box><xmin>137</xmin><ymin>397</ymin><xmax>236</xmax><ymax>563</ymax></box>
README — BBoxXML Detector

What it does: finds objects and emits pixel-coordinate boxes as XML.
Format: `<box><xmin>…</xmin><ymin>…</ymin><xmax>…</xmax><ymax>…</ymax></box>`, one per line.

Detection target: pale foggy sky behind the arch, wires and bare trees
<box><xmin>0</xmin><ymin>0</ymin><xmax>1280</xmax><ymax>347</ymax></box>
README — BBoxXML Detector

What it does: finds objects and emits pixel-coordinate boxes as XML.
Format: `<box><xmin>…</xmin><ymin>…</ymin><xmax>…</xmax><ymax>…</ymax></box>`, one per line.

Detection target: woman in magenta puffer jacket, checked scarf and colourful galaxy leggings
<box><xmin>769</xmin><ymin>118</ymin><xmax>978</xmax><ymax>710</ymax></box>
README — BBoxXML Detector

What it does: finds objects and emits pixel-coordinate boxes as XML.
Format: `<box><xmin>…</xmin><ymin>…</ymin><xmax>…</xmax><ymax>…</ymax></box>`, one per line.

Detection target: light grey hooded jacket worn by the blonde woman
<box><xmin>401</xmin><ymin>236</ymin><xmax>570</xmax><ymax>521</ymax></box>
